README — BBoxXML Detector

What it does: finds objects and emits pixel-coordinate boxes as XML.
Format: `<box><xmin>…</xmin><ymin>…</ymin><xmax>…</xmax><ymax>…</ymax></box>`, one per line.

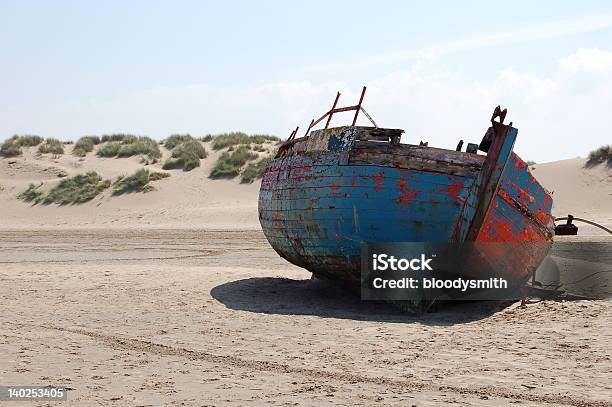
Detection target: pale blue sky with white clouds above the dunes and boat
<box><xmin>0</xmin><ymin>0</ymin><xmax>612</xmax><ymax>161</ymax></box>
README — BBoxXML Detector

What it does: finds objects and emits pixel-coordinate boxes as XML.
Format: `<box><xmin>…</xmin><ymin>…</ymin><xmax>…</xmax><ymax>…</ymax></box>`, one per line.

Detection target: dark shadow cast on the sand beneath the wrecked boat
<box><xmin>210</xmin><ymin>277</ymin><xmax>513</xmax><ymax>325</ymax></box>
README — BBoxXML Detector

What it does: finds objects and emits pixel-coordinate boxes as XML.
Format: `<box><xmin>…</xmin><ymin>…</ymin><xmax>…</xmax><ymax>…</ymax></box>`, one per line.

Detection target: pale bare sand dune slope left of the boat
<box><xmin>0</xmin><ymin>146</ymin><xmax>259</xmax><ymax>229</ymax></box>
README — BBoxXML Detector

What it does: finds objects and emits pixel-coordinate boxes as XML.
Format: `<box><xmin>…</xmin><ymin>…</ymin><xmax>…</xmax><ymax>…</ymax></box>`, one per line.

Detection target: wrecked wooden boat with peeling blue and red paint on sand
<box><xmin>259</xmin><ymin>87</ymin><xmax>554</xmax><ymax>300</ymax></box>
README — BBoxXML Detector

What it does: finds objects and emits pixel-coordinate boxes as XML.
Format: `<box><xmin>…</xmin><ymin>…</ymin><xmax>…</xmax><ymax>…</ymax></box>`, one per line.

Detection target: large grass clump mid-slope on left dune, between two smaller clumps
<box><xmin>41</xmin><ymin>171</ymin><xmax>111</xmax><ymax>205</ymax></box>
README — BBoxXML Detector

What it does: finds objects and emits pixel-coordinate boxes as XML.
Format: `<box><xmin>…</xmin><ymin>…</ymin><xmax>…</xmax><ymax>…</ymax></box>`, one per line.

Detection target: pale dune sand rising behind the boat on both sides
<box><xmin>0</xmin><ymin>146</ymin><xmax>612</xmax><ymax>234</ymax></box>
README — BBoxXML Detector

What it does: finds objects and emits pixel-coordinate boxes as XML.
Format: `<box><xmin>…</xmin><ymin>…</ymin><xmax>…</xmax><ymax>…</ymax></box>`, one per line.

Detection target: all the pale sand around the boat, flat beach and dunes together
<box><xmin>0</xmin><ymin>149</ymin><xmax>612</xmax><ymax>406</ymax></box>
